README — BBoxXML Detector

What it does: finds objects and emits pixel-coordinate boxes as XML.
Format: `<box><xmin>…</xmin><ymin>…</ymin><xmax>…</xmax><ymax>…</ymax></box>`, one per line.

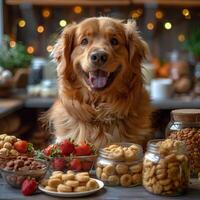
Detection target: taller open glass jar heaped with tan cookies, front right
<box><xmin>142</xmin><ymin>139</ymin><xmax>189</xmax><ymax>196</ymax></box>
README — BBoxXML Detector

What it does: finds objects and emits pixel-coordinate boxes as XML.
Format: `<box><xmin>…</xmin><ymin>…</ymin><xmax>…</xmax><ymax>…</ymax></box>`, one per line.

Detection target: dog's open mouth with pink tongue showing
<box><xmin>84</xmin><ymin>66</ymin><xmax>121</xmax><ymax>90</ymax></box>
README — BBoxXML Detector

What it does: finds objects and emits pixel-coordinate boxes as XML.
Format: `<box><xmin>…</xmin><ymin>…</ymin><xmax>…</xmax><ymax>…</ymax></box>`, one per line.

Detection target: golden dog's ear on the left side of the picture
<box><xmin>52</xmin><ymin>24</ymin><xmax>76</xmax><ymax>71</ymax></box>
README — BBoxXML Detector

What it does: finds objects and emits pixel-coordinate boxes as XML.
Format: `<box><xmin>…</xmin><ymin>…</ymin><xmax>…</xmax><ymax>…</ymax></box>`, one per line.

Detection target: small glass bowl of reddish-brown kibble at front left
<box><xmin>1</xmin><ymin>156</ymin><xmax>49</xmax><ymax>188</ymax></box>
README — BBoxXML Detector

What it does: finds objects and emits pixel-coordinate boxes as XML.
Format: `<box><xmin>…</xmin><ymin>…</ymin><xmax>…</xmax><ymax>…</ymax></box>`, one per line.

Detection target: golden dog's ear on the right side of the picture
<box><xmin>124</xmin><ymin>20</ymin><xmax>149</xmax><ymax>64</ymax></box>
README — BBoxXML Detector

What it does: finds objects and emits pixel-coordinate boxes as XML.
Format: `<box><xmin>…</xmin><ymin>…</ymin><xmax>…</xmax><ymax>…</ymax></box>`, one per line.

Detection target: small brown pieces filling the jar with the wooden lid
<box><xmin>169</xmin><ymin>128</ymin><xmax>200</xmax><ymax>176</ymax></box>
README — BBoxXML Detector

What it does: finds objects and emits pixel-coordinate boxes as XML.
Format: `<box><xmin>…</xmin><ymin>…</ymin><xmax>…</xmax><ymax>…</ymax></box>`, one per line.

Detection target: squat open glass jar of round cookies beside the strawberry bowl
<box><xmin>96</xmin><ymin>143</ymin><xmax>143</xmax><ymax>187</ymax></box>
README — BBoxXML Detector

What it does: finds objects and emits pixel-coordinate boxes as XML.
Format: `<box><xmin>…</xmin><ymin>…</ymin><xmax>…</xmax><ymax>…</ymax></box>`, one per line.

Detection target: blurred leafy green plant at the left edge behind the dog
<box><xmin>0</xmin><ymin>36</ymin><xmax>32</xmax><ymax>69</ymax></box>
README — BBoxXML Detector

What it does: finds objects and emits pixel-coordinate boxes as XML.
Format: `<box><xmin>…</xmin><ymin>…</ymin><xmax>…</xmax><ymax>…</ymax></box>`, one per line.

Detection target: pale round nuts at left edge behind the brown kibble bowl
<box><xmin>0</xmin><ymin>134</ymin><xmax>19</xmax><ymax>157</ymax></box>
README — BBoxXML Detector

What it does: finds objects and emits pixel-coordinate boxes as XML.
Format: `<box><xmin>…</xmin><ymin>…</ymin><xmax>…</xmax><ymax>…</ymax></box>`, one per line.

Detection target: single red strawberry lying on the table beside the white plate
<box><xmin>21</xmin><ymin>179</ymin><xmax>37</xmax><ymax>196</ymax></box>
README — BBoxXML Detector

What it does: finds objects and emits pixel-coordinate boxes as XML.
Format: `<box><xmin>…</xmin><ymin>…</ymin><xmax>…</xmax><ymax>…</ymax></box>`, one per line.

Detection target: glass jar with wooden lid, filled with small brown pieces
<box><xmin>166</xmin><ymin>109</ymin><xmax>200</xmax><ymax>177</ymax></box>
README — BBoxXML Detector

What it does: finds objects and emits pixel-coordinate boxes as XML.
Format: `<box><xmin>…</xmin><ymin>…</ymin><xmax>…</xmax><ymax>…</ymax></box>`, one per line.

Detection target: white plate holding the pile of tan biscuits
<box><xmin>38</xmin><ymin>178</ymin><xmax>104</xmax><ymax>197</ymax></box>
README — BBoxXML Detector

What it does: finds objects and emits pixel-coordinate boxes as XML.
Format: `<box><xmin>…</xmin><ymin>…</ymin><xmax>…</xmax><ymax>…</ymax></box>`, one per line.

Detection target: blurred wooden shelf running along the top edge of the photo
<box><xmin>6</xmin><ymin>0</ymin><xmax>200</xmax><ymax>7</ymax></box>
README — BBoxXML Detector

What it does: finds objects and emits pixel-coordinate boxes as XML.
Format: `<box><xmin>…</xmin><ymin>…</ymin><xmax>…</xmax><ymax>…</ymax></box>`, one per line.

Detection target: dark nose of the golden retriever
<box><xmin>90</xmin><ymin>51</ymin><xmax>108</xmax><ymax>66</ymax></box>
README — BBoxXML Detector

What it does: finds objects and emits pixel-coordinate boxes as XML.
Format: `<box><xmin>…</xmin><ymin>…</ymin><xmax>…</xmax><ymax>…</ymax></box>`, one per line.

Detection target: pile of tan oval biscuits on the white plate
<box><xmin>41</xmin><ymin>170</ymin><xmax>99</xmax><ymax>192</ymax></box>
